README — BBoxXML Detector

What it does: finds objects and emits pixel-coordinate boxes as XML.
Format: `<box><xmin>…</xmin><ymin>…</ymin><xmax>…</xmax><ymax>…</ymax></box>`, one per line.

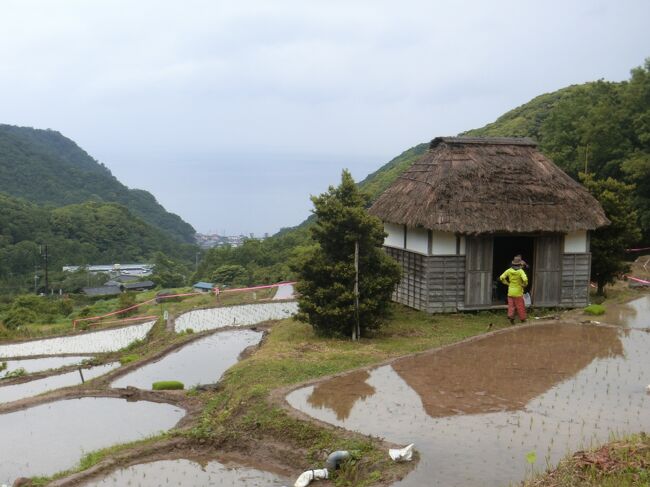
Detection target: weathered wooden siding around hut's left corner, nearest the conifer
<box><xmin>384</xmin><ymin>247</ymin><xmax>465</xmax><ymax>313</ymax></box>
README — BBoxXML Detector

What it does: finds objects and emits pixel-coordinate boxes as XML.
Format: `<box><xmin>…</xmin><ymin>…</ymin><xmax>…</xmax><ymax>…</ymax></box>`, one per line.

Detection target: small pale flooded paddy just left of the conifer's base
<box><xmin>175</xmin><ymin>302</ymin><xmax>298</xmax><ymax>333</ymax></box>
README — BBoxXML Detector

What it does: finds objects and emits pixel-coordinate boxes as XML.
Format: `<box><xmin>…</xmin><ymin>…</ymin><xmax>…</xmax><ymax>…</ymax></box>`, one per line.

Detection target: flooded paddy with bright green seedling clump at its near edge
<box><xmin>111</xmin><ymin>330</ymin><xmax>263</xmax><ymax>389</ymax></box>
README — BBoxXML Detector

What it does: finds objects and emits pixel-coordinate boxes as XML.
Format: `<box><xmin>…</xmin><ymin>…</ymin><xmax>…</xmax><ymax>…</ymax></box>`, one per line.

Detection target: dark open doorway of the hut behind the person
<box><xmin>492</xmin><ymin>236</ymin><xmax>535</xmax><ymax>304</ymax></box>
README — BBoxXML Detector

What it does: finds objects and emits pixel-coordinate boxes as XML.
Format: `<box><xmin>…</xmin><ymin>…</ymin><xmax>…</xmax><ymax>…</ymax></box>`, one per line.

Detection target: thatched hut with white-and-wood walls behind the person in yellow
<box><xmin>369</xmin><ymin>137</ymin><xmax>609</xmax><ymax>312</ymax></box>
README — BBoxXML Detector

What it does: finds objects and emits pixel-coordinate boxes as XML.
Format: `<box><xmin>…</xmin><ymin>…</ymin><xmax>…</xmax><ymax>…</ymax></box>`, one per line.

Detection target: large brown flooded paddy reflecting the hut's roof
<box><xmin>287</xmin><ymin>325</ymin><xmax>650</xmax><ymax>486</ymax></box>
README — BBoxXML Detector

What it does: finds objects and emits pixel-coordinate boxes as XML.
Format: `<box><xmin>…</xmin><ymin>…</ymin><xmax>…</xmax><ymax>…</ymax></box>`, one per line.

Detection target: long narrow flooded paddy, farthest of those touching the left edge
<box><xmin>0</xmin><ymin>321</ymin><xmax>155</xmax><ymax>358</ymax></box>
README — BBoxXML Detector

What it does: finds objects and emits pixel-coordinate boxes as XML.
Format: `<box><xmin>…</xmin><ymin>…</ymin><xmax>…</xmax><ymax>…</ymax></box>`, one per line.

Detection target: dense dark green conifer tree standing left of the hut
<box><xmin>295</xmin><ymin>170</ymin><xmax>400</xmax><ymax>336</ymax></box>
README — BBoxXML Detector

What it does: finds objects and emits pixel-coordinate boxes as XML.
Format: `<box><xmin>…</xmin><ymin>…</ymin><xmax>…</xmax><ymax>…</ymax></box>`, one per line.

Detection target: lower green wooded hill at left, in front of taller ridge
<box><xmin>0</xmin><ymin>194</ymin><xmax>195</xmax><ymax>288</ymax></box>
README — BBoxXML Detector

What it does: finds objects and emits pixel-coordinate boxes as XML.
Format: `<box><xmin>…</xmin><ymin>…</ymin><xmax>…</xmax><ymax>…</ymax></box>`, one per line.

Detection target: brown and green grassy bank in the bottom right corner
<box><xmin>523</xmin><ymin>433</ymin><xmax>650</xmax><ymax>487</ymax></box>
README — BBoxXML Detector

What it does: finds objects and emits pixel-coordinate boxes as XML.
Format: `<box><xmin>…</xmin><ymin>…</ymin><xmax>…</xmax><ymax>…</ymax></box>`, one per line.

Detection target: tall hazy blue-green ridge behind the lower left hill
<box><xmin>0</xmin><ymin>124</ymin><xmax>195</xmax><ymax>242</ymax></box>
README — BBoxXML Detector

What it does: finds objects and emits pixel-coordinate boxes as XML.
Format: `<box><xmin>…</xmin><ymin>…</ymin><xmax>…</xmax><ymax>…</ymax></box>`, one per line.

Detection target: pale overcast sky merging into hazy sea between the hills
<box><xmin>0</xmin><ymin>0</ymin><xmax>650</xmax><ymax>234</ymax></box>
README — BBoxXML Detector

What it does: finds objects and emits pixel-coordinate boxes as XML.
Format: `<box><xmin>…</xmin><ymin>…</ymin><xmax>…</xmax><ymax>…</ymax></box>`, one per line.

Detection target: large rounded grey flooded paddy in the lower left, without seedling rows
<box><xmin>0</xmin><ymin>397</ymin><xmax>185</xmax><ymax>485</ymax></box>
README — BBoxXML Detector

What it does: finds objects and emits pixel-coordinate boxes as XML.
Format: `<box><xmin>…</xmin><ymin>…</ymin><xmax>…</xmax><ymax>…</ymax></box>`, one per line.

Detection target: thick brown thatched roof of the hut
<box><xmin>370</xmin><ymin>137</ymin><xmax>609</xmax><ymax>234</ymax></box>
